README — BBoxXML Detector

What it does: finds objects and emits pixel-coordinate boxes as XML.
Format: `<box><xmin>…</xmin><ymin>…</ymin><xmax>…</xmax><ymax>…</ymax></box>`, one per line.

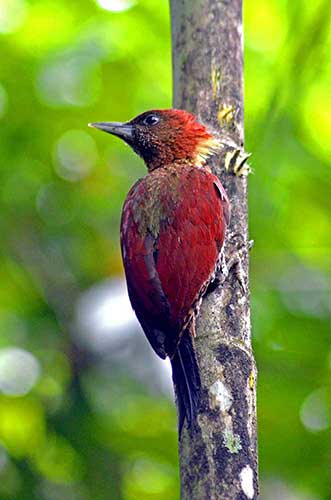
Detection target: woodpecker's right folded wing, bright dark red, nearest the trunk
<box><xmin>156</xmin><ymin>169</ymin><xmax>226</xmax><ymax>332</ymax></box>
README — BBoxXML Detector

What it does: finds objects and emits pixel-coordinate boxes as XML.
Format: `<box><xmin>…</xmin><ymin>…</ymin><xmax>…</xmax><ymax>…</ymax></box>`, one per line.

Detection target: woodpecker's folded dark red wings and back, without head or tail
<box><xmin>121</xmin><ymin>168</ymin><xmax>229</xmax><ymax>357</ymax></box>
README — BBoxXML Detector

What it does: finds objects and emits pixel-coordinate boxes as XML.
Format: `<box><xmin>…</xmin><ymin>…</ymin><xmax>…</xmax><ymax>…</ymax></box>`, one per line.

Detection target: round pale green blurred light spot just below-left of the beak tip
<box><xmin>55</xmin><ymin>130</ymin><xmax>98</xmax><ymax>181</ymax></box>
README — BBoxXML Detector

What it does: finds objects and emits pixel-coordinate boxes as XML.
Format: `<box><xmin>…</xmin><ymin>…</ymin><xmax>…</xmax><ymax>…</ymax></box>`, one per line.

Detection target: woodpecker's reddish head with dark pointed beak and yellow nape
<box><xmin>89</xmin><ymin>109</ymin><xmax>220</xmax><ymax>171</ymax></box>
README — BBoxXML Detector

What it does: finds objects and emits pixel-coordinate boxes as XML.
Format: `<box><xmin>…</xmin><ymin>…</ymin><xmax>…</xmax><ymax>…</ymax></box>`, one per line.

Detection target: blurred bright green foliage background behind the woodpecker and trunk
<box><xmin>0</xmin><ymin>0</ymin><xmax>331</xmax><ymax>500</ymax></box>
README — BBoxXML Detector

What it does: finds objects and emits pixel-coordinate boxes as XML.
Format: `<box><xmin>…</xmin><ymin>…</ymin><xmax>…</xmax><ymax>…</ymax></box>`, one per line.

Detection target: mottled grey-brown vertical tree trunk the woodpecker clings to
<box><xmin>171</xmin><ymin>0</ymin><xmax>258</xmax><ymax>500</ymax></box>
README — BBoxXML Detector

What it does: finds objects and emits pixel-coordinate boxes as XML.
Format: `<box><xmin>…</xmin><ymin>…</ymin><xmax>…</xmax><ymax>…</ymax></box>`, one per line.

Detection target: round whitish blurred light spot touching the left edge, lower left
<box><xmin>0</xmin><ymin>347</ymin><xmax>40</xmax><ymax>396</ymax></box>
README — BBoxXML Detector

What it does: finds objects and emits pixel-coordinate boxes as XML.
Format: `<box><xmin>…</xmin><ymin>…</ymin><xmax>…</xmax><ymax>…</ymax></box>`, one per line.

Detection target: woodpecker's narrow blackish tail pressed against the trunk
<box><xmin>171</xmin><ymin>330</ymin><xmax>201</xmax><ymax>436</ymax></box>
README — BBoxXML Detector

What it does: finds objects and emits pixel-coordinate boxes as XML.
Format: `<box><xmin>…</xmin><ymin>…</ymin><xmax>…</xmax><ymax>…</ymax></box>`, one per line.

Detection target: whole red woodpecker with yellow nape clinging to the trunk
<box><xmin>90</xmin><ymin>109</ymin><xmax>230</xmax><ymax>433</ymax></box>
